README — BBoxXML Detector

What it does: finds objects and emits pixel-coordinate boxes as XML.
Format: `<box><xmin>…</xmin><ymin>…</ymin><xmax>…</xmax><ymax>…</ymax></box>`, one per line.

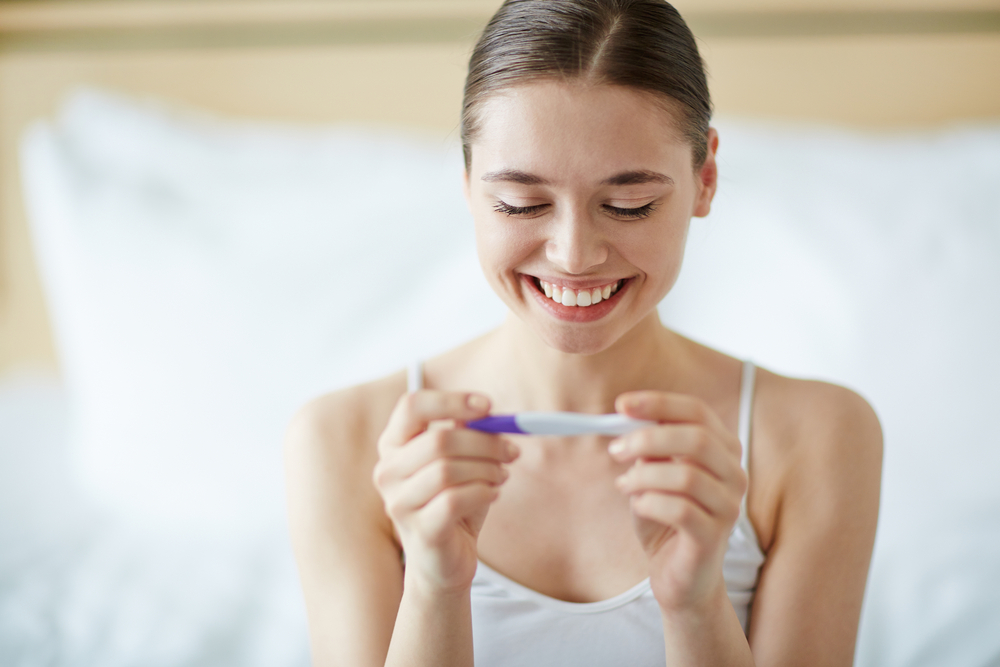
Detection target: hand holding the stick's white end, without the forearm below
<box><xmin>608</xmin><ymin>391</ymin><xmax>747</xmax><ymax>611</ymax></box>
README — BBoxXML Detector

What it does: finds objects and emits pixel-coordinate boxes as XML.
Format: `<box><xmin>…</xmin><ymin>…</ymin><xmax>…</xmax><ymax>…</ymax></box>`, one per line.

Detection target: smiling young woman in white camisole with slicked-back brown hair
<box><xmin>286</xmin><ymin>0</ymin><xmax>881</xmax><ymax>667</ymax></box>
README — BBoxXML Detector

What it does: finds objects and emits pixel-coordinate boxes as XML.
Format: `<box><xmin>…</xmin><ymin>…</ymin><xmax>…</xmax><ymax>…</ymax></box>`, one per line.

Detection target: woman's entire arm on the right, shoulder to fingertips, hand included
<box><xmin>612</xmin><ymin>374</ymin><xmax>882</xmax><ymax>667</ymax></box>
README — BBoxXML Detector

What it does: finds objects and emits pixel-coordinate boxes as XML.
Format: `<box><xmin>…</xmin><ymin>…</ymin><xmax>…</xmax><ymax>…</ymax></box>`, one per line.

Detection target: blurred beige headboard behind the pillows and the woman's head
<box><xmin>0</xmin><ymin>0</ymin><xmax>1000</xmax><ymax>372</ymax></box>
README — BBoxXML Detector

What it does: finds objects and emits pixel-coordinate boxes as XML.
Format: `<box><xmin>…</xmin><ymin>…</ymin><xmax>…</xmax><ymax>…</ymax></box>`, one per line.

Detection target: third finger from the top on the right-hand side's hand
<box><xmin>615</xmin><ymin>461</ymin><xmax>743</xmax><ymax>522</ymax></box>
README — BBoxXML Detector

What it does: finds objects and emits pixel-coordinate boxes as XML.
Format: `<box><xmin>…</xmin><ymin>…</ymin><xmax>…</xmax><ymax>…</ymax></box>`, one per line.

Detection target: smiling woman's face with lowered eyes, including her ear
<box><xmin>466</xmin><ymin>81</ymin><xmax>717</xmax><ymax>354</ymax></box>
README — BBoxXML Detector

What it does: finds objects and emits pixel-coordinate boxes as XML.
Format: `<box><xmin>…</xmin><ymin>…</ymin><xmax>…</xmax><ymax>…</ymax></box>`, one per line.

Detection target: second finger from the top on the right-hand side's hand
<box><xmin>608</xmin><ymin>424</ymin><xmax>745</xmax><ymax>483</ymax></box>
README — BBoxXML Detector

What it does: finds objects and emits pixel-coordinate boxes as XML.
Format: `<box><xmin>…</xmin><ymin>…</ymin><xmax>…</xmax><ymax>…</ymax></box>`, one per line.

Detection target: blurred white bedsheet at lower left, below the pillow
<box><xmin>0</xmin><ymin>374</ymin><xmax>309</xmax><ymax>667</ymax></box>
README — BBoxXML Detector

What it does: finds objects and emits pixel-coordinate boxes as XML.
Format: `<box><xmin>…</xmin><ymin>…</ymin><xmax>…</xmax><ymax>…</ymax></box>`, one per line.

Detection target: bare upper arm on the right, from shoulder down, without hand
<box><xmin>750</xmin><ymin>376</ymin><xmax>882</xmax><ymax>667</ymax></box>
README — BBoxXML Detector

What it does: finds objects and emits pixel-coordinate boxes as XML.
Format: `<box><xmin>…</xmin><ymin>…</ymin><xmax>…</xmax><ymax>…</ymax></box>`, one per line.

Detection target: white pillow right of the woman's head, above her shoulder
<box><xmin>661</xmin><ymin>121</ymin><xmax>1000</xmax><ymax>506</ymax></box>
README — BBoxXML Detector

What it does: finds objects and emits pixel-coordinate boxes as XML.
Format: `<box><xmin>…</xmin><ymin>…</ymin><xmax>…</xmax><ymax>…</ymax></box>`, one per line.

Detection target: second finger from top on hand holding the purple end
<box><xmin>384</xmin><ymin>429</ymin><xmax>520</xmax><ymax>479</ymax></box>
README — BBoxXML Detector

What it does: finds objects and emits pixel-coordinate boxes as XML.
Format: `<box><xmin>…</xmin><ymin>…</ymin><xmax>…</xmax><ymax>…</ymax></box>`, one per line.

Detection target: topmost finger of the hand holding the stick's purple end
<box><xmin>379</xmin><ymin>389</ymin><xmax>490</xmax><ymax>451</ymax></box>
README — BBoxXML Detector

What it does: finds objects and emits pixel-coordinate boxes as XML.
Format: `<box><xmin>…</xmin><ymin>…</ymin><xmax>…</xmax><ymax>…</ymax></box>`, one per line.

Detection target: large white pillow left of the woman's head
<box><xmin>23</xmin><ymin>91</ymin><xmax>503</xmax><ymax>530</ymax></box>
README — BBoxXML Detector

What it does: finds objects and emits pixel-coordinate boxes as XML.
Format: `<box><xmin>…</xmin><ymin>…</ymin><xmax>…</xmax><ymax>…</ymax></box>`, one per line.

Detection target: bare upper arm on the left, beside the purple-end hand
<box><xmin>285</xmin><ymin>388</ymin><xmax>403</xmax><ymax>667</ymax></box>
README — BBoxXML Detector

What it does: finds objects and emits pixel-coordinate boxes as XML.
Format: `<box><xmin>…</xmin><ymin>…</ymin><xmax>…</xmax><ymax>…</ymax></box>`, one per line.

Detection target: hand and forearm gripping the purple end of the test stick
<box><xmin>373</xmin><ymin>390</ymin><xmax>517</xmax><ymax>667</ymax></box>
